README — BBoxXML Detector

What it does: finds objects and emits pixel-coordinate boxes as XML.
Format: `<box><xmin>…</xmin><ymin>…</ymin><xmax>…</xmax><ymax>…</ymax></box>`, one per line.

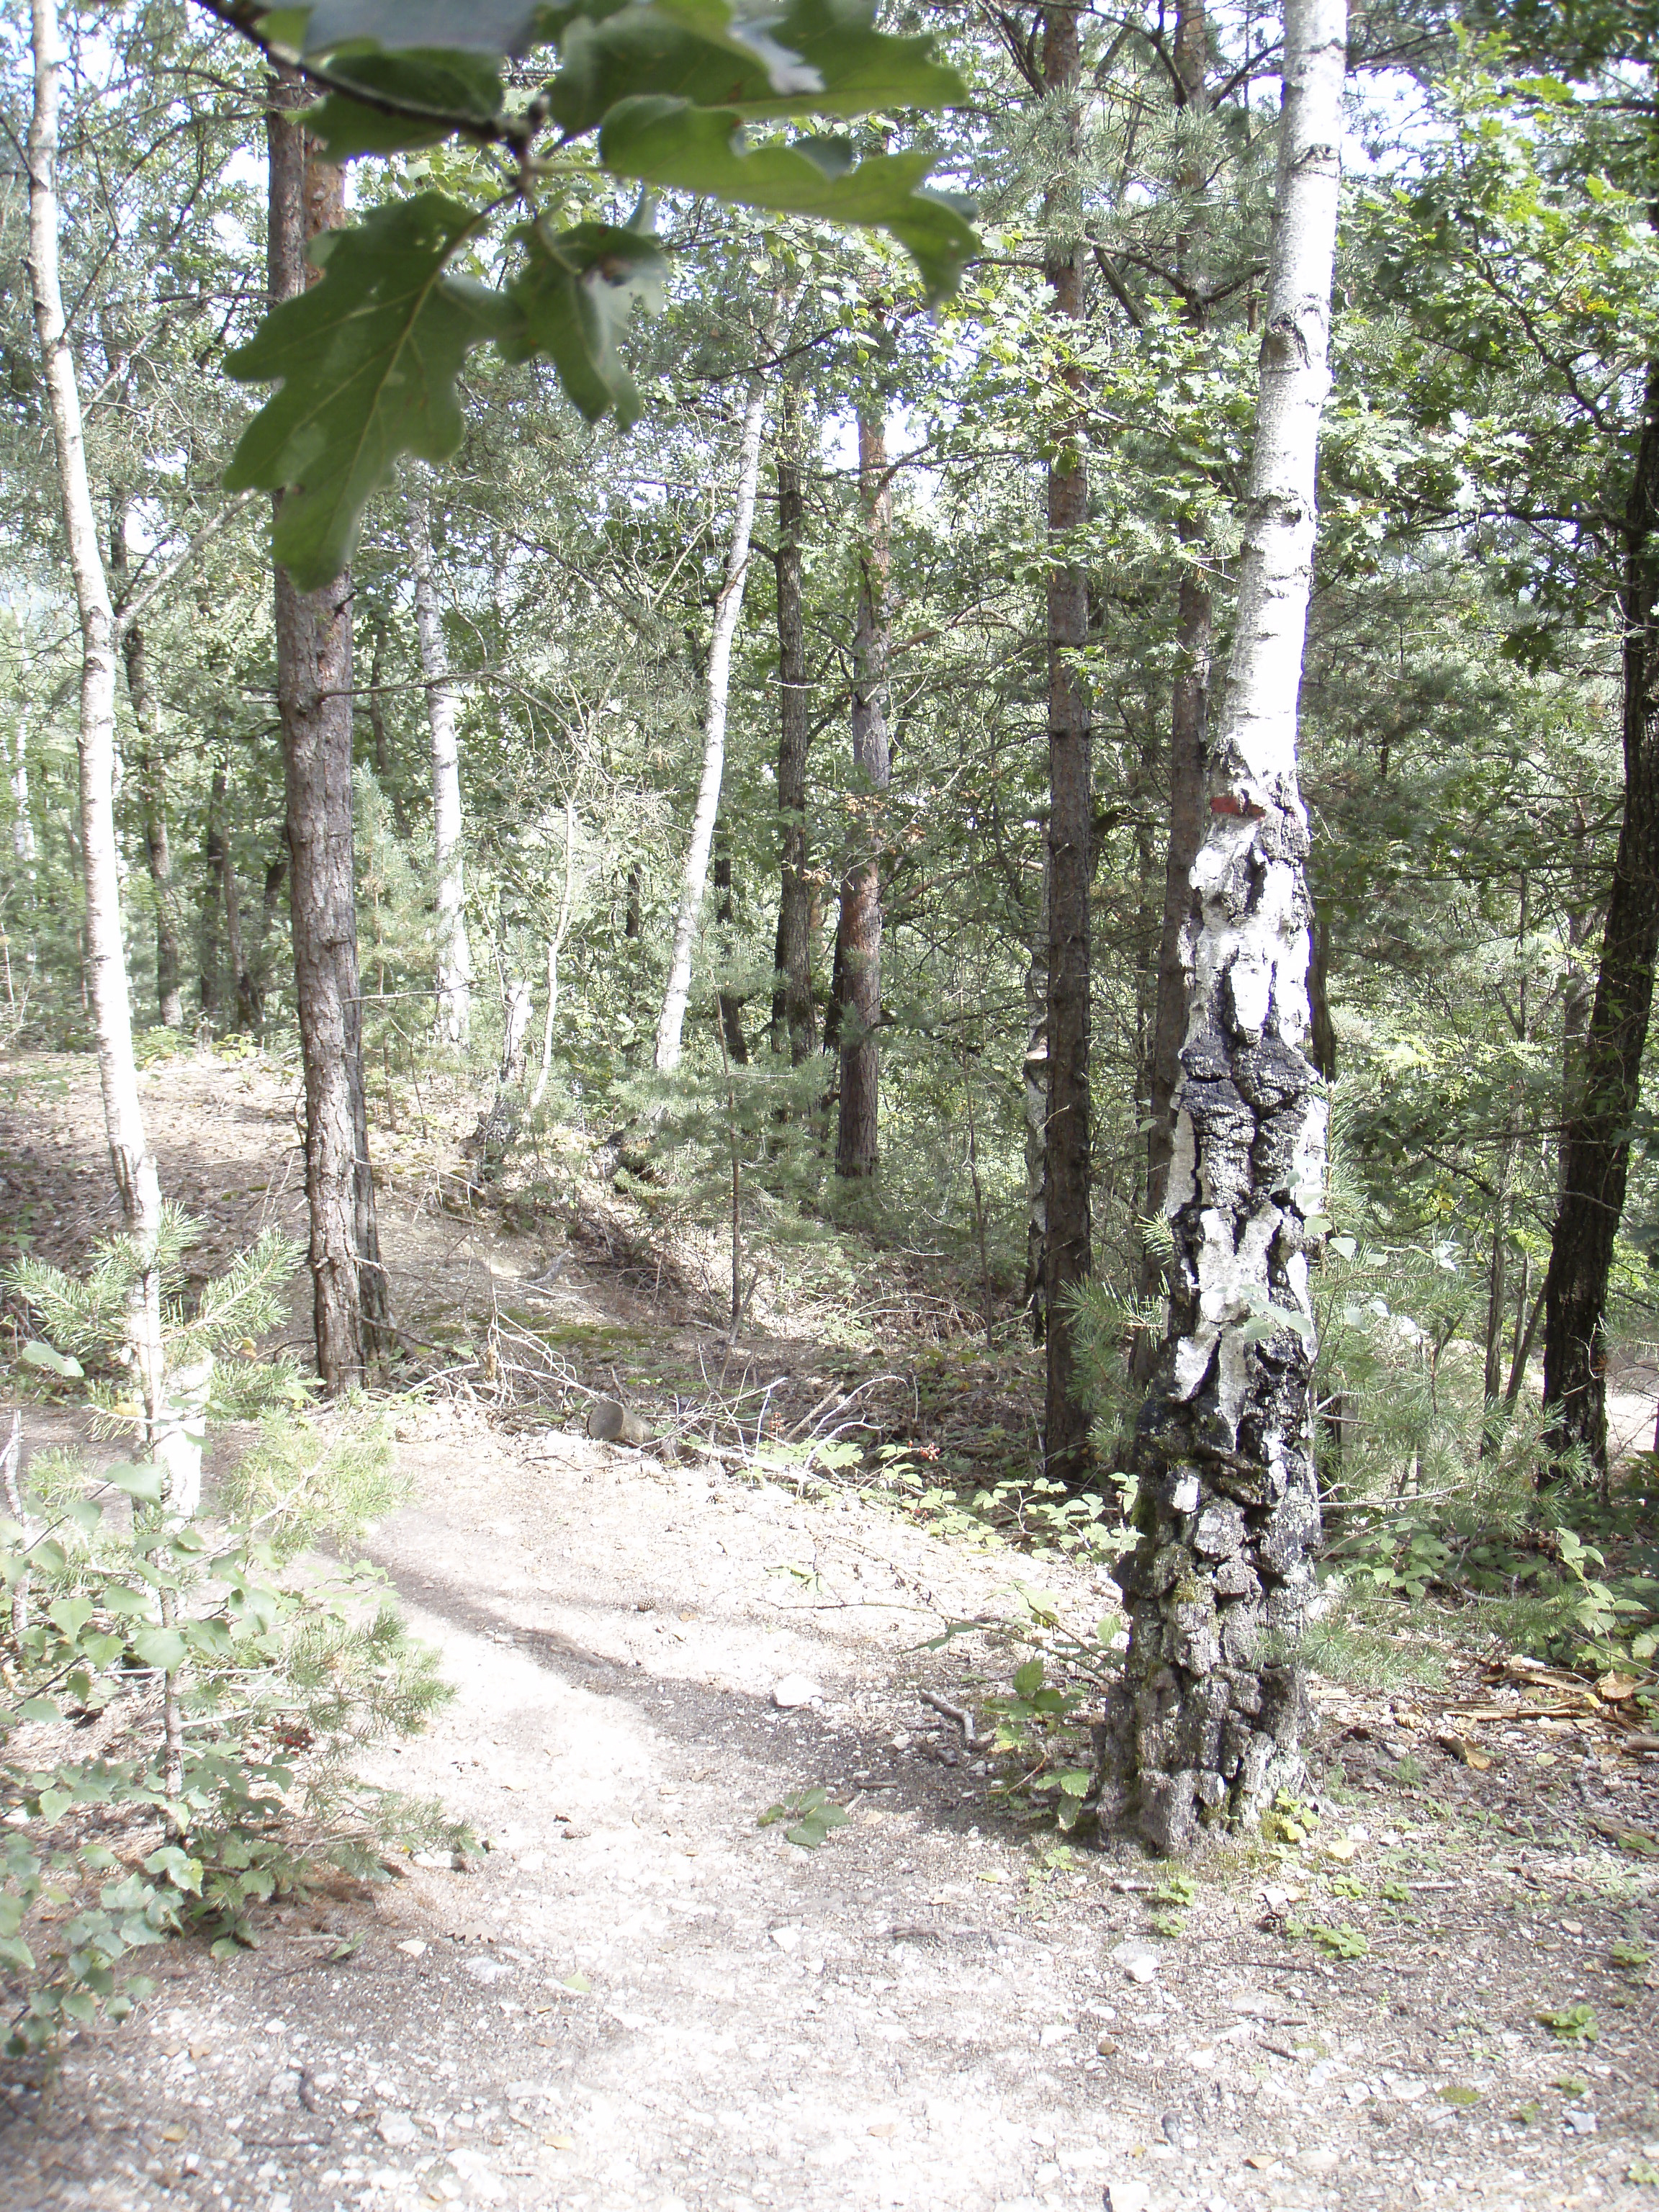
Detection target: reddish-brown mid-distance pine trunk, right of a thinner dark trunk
<box><xmin>836</xmin><ymin>413</ymin><xmax>894</xmax><ymax>1177</ymax></box>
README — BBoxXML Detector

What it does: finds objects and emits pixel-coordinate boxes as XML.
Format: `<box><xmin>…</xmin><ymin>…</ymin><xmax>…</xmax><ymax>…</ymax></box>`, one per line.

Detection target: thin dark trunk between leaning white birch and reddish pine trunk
<box><xmin>772</xmin><ymin>385</ymin><xmax>814</xmax><ymax>1069</ymax></box>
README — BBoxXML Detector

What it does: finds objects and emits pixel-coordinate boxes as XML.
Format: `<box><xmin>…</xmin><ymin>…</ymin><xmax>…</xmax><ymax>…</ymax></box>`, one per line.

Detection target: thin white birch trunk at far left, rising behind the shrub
<box><xmin>27</xmin><ymin>0</ymin><xmax>163</xmax><ymax>1434</ymax></box>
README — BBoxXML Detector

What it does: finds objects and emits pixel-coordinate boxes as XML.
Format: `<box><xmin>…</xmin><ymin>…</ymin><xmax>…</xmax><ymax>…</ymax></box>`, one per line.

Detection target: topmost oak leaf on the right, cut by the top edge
<box><xmin>549</xmin><ymin>0</ymin><xmax>964</xmax><ymax>132</ymax></box>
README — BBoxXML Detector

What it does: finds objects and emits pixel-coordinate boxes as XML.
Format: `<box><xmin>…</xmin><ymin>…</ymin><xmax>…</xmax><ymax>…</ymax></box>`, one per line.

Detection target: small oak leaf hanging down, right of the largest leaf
<box><xmin>504</xmin><ymin>223</ymin><xmax>664</xmax><ymax>429</ymax></box>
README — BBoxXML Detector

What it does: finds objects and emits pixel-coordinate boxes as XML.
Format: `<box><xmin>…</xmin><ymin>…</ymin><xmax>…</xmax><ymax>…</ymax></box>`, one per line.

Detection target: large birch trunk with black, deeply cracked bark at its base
<box><xmin>1106</xmin><ymin>0</ymin><xmax>1345</xmax><ymax>1851</ymax></box>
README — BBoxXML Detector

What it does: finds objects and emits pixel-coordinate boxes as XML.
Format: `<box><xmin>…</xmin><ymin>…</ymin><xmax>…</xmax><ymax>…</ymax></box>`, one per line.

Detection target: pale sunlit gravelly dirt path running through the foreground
<box><xmin>0</xmin><ymin>1053</ymin><xmax>1659</xmax><ymax>2212</ymax></box>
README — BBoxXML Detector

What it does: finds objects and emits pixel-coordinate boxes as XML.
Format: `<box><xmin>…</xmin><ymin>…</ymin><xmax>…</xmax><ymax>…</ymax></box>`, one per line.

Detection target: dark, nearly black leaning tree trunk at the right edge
<box><xmin>1544</xmin><ymin>363</ymin><xmax>1659</xmax><ymax>1471</ymax></box>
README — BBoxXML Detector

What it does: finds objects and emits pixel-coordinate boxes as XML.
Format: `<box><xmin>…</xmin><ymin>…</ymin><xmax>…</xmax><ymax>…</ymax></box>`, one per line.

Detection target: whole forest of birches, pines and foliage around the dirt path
<box><xmin>0</xmin><ymin>0</ymin><xmax>1659</xmax><ymax>2141</ymax></box>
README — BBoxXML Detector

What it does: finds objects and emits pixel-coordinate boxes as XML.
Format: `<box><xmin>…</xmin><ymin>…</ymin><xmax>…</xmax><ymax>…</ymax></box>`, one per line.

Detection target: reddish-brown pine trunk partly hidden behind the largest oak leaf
<box><xmin>268</xmin><ymin>68</ymin><xmax>387</xmax><ymax>1393</ymax></box>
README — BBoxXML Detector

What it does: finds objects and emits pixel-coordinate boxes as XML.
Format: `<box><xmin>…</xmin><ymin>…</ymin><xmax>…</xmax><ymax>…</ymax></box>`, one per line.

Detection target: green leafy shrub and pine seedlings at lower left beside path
<box><xmin>0</xmin><ymin>1226</ymin><xmax>469</xmax><ymax>2051</ymax></box>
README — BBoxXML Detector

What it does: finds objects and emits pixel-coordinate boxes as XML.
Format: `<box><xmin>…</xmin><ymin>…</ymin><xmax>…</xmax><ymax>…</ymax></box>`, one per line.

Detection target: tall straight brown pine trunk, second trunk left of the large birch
<box><xmin>1042</xmin><ymin>9</ymin><xmax>1095</xmax><ymax>1484</ymax></box>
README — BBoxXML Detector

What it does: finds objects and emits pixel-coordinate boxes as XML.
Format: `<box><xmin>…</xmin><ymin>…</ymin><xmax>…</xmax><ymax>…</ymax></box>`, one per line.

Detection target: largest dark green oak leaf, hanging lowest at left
<box><xmin>225</xmin><ymin>192</ymin><xmax>518</xmax><ymax>590</ymax></box>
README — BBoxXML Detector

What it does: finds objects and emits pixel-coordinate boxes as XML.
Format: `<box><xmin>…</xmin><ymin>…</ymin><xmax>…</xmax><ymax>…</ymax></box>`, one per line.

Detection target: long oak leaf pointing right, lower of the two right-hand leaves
<box><xmin>601</xmin><ymin>97</ymin><xmax>980</xmax><ymax>302</ymax></box>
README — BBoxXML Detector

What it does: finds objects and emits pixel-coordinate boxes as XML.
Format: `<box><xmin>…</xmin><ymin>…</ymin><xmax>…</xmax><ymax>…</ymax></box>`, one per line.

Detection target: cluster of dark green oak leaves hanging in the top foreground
<box><xmin>225</xmin><ymin>0</ymin><xmax>978</xmax><ymax>590</ymax></box>
